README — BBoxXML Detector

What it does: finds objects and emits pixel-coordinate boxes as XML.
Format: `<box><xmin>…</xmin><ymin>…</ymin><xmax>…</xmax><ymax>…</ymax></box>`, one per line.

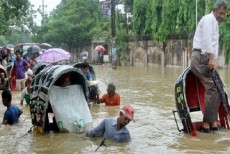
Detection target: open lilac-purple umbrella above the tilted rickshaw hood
<box><xmin>36</xmin><ymin>48</ymin><xmax>71</xmax><ymax>63</ymax></box>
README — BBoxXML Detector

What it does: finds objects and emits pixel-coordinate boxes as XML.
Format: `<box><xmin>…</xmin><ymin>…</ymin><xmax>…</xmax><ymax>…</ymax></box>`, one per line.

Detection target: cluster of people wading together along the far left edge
<box><xmin>0</xmin><ymin>48</ymin><xmax>33</xmax><ymax>125</ymax></box>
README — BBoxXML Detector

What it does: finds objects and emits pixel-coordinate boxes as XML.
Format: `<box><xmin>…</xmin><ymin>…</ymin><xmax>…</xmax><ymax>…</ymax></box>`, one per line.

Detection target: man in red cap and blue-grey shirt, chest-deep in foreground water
<box><xmin>86</xmin><ymin>105</ymin><xmax>134</xmax><ymax>142</ymax></box>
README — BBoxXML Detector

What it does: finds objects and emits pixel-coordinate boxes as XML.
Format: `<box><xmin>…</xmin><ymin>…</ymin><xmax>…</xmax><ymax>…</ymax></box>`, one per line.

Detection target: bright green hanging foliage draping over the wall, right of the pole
<box><xmin>131</xmin><ymin>0</ymin><xmax>230</xmax><ymax>63</ymax></box>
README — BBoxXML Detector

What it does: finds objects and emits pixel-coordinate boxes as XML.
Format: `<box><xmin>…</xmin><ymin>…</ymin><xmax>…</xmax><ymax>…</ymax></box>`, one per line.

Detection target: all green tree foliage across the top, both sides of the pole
<box><xmin>0</xmin><ymin>0</ymin><xmax>230</xmax><ymax>63</ymax></box>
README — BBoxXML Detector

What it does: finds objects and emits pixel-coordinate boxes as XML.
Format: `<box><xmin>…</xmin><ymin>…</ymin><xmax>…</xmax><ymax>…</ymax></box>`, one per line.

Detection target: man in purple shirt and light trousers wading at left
<box><xmin>9</xmin><ymin>50</ymin><xmax>29</xmax><ymax>91</ymax></box>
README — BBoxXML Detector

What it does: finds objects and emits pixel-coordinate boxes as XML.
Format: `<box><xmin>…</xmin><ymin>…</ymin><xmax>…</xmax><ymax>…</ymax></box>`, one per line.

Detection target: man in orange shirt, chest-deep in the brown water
<box><xmin>97</xmin><ymin>83</ymin><xmax>120</xmax><ymax>106</ymax></box>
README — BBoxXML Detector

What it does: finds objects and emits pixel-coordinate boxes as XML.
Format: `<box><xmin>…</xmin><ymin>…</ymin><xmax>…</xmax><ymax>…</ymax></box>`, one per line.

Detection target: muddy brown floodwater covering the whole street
<box><xmin>0</xmin><ymin>65</ymin><xmax>230</xmax><ymax>154</ymax></box>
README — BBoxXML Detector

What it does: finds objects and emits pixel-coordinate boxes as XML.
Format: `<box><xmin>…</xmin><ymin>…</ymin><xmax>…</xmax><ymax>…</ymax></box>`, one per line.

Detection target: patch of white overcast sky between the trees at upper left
<box><xmin>30</xmin><ymin>0</ymin><xmax>61</xmax><ymax>24</ymax></box>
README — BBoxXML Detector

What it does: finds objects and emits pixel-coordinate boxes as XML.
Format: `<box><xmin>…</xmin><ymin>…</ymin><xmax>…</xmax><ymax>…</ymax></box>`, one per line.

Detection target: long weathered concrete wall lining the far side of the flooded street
<box><xmin>70</xmin><ymin>39</ymin><xmax>224</xmax><ymax>68</ymax></box>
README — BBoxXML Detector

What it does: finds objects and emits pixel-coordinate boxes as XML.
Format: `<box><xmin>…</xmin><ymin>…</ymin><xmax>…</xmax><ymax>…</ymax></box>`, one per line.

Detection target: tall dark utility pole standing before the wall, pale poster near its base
<box><xmin>111</xmin><ymin>0</ymin><xmax>117</xmax><ymax>69</ymax></box>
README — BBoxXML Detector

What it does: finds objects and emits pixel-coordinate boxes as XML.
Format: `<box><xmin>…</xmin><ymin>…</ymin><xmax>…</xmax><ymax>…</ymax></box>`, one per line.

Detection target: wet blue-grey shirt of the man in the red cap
<box><xmin>87</xmin><ymin>118</ymin><xmax>131</xmax><ymax>142</ymax></box>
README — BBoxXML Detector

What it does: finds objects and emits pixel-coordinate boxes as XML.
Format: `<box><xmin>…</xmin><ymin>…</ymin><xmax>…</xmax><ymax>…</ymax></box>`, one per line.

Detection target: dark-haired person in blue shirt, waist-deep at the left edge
<box><xmin>2</xmin><ymin>90</ymin><xmax>23</xmax><ymax>125</ymax></box>
